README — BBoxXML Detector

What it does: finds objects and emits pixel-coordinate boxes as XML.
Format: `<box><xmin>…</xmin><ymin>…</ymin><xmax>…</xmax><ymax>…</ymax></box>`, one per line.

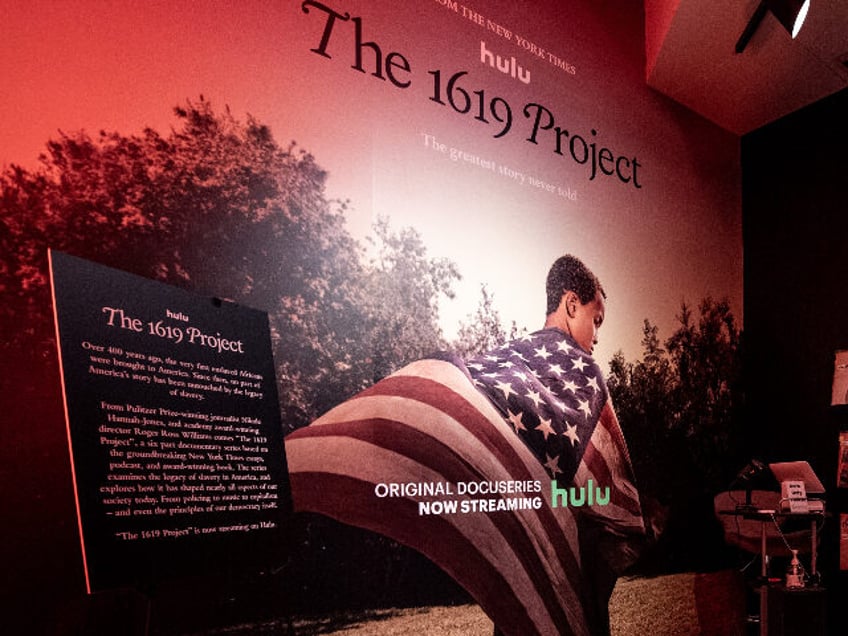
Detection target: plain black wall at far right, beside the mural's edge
<box><xmin>742</xmin><ymin>91</ymin><xmax>848</xmax><ymax>633</ymax></box>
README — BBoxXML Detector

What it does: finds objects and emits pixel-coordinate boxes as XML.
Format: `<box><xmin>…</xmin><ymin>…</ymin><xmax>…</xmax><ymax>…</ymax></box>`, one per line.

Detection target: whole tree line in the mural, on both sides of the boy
<box><xmin>0</xmin><ymin>98</ymin><xmax>741</xmax><ymax>592</ymax></box>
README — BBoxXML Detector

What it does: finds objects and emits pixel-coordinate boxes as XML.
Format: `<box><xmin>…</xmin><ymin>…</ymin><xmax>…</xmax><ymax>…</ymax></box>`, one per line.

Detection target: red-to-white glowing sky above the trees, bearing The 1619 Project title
<box><xmin>0</xmin><ymin>0</ymin><xmax>742</xmax><ymax>362</ymax></box>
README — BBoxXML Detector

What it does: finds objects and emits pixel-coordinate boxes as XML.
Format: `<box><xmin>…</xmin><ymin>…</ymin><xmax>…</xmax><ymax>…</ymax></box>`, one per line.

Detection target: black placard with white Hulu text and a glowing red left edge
<box><xmin>50</xmin><ymin>251</ymin><xmax>290</xmax><ymax>591</ymax></box>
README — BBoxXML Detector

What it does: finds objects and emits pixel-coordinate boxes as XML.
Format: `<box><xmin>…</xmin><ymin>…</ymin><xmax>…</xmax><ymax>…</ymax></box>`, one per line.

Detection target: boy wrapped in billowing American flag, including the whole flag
<box><xmin>286</xmin><ymin>255</ymin><xmax>645</xmax><ymax>636</ymax></box>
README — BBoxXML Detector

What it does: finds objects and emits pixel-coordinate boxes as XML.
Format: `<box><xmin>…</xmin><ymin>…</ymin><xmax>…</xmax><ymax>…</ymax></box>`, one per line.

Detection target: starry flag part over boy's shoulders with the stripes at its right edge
<box><xmin>467</xmin><ymin>327</ymin><xmax>642</xmax><ymax>530</ymax></box>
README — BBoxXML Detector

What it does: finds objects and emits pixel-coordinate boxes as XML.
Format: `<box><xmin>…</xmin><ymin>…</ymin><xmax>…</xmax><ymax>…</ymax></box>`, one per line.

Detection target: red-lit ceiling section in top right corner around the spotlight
<box><xmin>644</xmin><ymin>0</ymin><xmax>848</xmax><ymax>135</ymax></box>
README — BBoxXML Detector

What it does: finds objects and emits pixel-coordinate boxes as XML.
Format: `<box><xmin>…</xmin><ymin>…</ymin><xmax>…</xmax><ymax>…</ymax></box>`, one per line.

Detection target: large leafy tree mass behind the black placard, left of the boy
<box><xmin>0</xmin><ymin>97</ymin><xmax>458</xmax><ymax>428</ymax></box>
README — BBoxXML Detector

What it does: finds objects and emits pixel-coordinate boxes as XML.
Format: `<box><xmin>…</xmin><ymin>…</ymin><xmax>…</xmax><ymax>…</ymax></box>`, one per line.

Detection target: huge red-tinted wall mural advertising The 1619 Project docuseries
<box><xmin>0</xmin><ymin>0</ymin><xmax>747</xmax><ymax>634</ymax></box>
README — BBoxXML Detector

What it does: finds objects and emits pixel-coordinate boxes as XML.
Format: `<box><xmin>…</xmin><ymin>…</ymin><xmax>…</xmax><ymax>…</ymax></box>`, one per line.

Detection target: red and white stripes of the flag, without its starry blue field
<box><xmin>286</xmin><ymin>332</ymin><xmax>641</xmax><ymax>636</ymax></box>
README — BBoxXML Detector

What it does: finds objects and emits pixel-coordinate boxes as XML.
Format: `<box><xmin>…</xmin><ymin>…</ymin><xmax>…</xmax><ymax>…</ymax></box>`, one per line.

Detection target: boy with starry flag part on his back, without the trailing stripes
<box><xmin>466</xmin><ymin>255</ymin><xmax>645</xmax><ymax>636</ymax></box>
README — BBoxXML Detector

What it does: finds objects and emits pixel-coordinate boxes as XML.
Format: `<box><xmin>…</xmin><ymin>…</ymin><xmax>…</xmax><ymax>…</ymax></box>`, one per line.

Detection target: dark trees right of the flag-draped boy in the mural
<box><xmin>609</xmin><ymin>298</ymin><xmax>742</xmax><ymax>496</ymax></box>
